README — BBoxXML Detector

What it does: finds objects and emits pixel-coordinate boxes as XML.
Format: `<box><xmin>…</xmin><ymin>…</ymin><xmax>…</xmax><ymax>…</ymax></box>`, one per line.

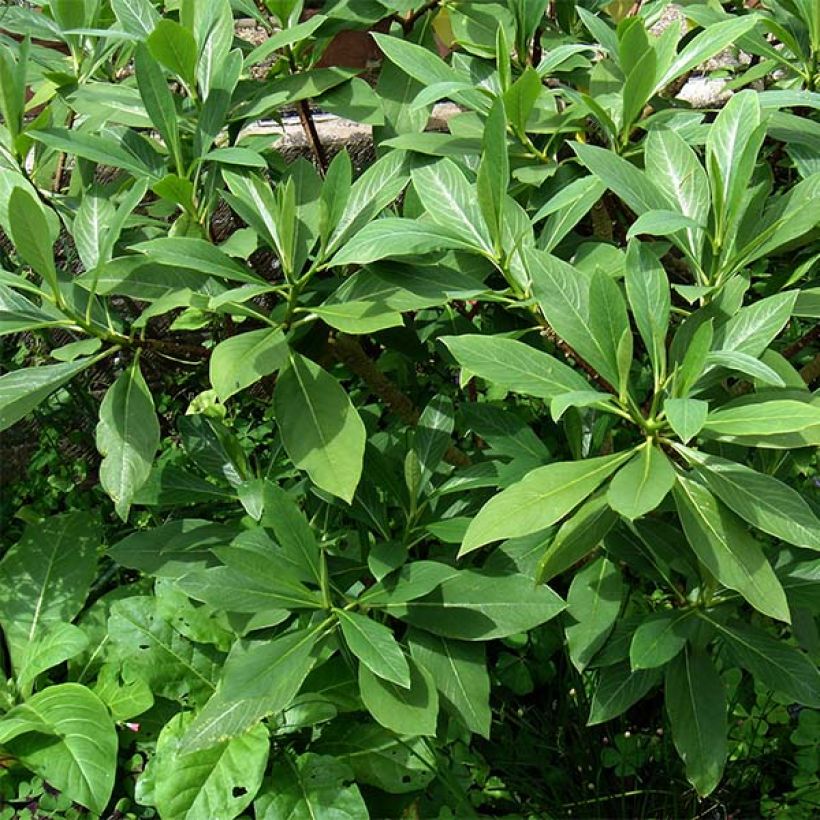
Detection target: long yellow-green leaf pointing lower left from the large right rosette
<box><xmin>459</xmin><ymin>452</ymin><xmax>631</xmax><ymax>555</ymax></box>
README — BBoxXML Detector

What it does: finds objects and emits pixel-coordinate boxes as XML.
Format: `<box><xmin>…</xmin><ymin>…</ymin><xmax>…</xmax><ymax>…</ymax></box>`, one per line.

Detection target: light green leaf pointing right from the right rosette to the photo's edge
<box><xmin>703</xmin><ymin>399</ymin><xmax>820</xmax><ymax>441</ymax></box>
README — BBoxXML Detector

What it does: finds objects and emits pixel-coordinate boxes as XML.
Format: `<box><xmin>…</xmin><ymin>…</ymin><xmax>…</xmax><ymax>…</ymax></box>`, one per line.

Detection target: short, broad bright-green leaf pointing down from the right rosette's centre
<box><xmin>606</xmin><ymin>441</ymin><xmax>675</xmax><ymax>521</ymax></box>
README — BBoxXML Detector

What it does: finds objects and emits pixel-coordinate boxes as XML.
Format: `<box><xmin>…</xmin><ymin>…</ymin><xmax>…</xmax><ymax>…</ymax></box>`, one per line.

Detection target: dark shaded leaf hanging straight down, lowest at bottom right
<box><xmin>664</xmin><ymin>647</ymin><xmax>728</xmax><ymax>797</ymax></box>
